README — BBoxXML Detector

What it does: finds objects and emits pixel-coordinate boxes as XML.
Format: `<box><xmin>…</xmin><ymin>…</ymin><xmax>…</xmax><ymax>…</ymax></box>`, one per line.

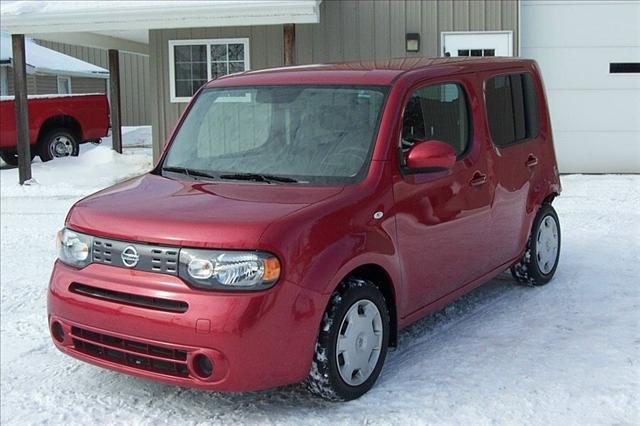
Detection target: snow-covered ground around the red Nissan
<box><xmin>0</xmin><ymin>135</ymin><xmax>640</xmax><ymax>425</ymax></box>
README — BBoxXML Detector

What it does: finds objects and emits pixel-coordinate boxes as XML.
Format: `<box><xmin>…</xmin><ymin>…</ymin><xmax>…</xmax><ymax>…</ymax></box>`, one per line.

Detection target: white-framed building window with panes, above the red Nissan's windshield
<box><xmin>169</xmin><ymin>38</ymin><xmax>249</xmax><ymax>102</ymax></box>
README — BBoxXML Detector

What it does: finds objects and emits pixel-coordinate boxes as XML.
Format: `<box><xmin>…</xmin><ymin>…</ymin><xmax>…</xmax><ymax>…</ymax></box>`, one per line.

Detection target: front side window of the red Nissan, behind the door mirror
<box><xmin>402</xmin><ymin>83</ymin><xmax>469</xmax><ymax>155</ymax></box>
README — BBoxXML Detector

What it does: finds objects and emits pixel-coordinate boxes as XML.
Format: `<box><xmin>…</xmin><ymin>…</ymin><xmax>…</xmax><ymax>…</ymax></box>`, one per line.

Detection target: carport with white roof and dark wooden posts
<box><xmin>1</xmin><ymin>0</ymin><xmax>320</xmax><ymax>184</ymax></box>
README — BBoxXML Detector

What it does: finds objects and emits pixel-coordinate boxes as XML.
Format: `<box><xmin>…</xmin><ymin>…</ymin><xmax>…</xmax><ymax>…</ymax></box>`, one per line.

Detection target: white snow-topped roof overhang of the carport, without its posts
<box><xmin>0</xmin><ymin>0</ymin><xmax>322</xmax><ymax>54</ymax></box>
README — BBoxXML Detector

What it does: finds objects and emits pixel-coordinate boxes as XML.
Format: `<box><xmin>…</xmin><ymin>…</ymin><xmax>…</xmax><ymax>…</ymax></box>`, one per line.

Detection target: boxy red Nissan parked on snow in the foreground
<box><xmin>48</xmin><ymin>58</ymin><xmax>561</xmax><ymax>401</ymax></box>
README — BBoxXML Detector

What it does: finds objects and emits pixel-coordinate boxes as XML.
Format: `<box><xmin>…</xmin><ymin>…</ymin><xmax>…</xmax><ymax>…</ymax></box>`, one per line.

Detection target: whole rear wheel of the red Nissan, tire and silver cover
<box><xmin>511</xmin><ymin>204</ymin><xmax>560</xmax><ymax>286</ymax></box>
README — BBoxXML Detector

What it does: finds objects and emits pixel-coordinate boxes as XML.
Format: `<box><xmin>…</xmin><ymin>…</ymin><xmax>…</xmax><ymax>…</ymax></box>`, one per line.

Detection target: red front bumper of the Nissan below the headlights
<box><xmin>48</xmin><ymin>262</ymin><xmax>326</xmax><ymax>391</ymax></box>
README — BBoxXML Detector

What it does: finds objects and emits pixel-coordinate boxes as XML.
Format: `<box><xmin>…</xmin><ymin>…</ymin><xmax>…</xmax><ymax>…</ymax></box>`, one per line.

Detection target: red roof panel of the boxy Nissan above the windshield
<box><xmin>207</xmin><ymin>57</ymin><xmax>532</xmax><ymax>87</ymax></box>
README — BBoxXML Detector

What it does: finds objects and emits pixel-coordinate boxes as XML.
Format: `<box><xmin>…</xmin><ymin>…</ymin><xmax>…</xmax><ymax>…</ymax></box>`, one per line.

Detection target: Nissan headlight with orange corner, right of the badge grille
<box><xmin>178</xmin><ymin>249</ymin><xmax>280</xmax><ymax>290</ymax></box>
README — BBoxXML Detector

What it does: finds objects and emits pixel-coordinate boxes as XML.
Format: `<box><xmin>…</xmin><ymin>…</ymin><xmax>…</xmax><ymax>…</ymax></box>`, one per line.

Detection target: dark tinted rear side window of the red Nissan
<box><xmin>485</xmin><ymin>73</ymin><xmax>540</xmax><ymax>146</ymax></box>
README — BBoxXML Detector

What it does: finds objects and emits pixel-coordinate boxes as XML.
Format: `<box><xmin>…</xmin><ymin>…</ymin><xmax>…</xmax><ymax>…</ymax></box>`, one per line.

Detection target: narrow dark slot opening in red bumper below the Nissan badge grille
<box><xmin>69</xmin><ymin>283</ymin><xmax>189</xmax><ymax>313</ymax></box>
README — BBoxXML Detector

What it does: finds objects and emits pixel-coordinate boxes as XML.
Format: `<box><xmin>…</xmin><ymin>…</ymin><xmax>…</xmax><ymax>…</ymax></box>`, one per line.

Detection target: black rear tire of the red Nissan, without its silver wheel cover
<box><xmin>511</xmin><ymin>204</ymin><xmax>561</xmax><ymax>286</ymax></box>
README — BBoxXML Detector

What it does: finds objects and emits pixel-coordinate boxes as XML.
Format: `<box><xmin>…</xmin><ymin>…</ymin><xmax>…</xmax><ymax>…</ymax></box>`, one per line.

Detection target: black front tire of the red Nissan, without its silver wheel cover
<box><xmin>305</xmin><ymin>277</ymin><xmax>389</xmax><ymax>401</ymax></box>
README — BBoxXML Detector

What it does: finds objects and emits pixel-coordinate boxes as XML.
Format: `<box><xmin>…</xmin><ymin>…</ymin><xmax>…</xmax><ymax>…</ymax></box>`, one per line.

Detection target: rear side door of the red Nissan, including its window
<box><xmin>484</xmin><ymin>71</ymin><xmax>543</xmax><ymax>264</ymax></box>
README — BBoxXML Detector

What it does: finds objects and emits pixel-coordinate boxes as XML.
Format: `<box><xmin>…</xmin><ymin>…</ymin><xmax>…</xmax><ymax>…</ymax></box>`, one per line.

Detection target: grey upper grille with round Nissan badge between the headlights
<box><xmin>92</xmin><ymin>237</ymin><xmax>179</xmax><ymax>275</ymax></box>
